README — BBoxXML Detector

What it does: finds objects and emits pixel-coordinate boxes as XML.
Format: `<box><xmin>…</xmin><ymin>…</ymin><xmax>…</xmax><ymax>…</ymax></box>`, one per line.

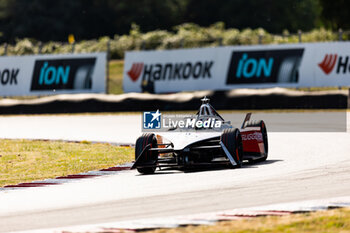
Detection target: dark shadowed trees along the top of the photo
<box><xmin>0</xmin><ymin>0</ymin><xmax>350</xmax><ymax>43</ymax></box>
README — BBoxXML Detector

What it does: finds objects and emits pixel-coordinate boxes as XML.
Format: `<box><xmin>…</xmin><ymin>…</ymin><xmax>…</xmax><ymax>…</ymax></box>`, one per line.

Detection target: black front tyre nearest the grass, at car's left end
<box><xmin>135</xmin><ymin>133</ymin><xmax>158</xmax><ymax>174</ymax></box>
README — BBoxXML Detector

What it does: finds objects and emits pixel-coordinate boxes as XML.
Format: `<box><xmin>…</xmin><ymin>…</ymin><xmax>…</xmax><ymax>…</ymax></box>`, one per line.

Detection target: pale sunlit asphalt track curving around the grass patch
<box><xmin>0</xmin><ymin>112</ymin><xmax>350</xmax><ymax>232</ymax></box>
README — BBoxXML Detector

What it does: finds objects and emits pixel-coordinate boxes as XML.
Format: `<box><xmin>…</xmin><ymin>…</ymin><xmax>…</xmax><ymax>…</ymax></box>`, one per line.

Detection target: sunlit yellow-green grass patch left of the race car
<box><xmin>0</xmin><ymin>140</ymin><xmax>134</xmax><ymax>187</ymax></box>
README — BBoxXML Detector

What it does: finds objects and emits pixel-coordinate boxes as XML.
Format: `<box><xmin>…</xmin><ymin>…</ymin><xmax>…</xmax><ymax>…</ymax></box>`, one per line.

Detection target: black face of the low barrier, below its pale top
<box><xmin>0</xmin><ymin>91</ymin><xmax>348</xmax><ymax>114</ymax></box>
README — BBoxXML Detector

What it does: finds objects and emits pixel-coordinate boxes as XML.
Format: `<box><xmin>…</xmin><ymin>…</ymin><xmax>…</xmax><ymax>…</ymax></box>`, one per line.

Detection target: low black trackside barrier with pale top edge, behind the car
<box><xmin>0</xmin><ymin>88</ymin><xmax>349</xmax><ymax>114</ymax></box>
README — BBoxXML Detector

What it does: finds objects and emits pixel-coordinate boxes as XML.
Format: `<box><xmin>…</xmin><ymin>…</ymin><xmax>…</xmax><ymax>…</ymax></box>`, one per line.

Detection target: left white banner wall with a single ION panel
<box><xmin>0</xmin><ymin>53</ymin><xmax>106</xmax><ymax>96</ymax></box>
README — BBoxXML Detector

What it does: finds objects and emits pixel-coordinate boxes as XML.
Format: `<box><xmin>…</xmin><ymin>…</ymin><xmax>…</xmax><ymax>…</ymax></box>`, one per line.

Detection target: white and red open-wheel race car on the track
<box><xmin>131</xmin><ymin>97</ymin><xmax>268</xmax><ymax>174</ymax></box>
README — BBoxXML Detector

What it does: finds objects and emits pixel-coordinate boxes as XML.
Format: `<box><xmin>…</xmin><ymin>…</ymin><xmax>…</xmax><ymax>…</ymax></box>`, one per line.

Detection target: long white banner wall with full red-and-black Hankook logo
<box><xmin>123</xmin><ymin>42</ymin><xmax>350</xmax><ymax>93</ymax></box>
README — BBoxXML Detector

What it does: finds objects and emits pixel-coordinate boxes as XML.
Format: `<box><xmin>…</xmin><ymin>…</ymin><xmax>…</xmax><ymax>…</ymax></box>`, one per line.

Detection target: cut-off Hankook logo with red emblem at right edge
<box><xmin>318</xmin><ymin>54</ymin><xmax>350</xmax><ymax>75</ymax></box>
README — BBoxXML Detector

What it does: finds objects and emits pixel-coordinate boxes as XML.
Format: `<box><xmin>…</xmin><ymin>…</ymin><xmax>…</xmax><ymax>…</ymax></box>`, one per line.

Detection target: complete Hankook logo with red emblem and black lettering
<box><xmin>127</xmin><ymin>61</ymin><xmax>214</xmax><ymax>93</ymax></box>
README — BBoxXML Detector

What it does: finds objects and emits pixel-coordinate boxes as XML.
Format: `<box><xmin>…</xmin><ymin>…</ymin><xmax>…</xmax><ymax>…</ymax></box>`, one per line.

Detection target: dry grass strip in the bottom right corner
<box><xmin>149</xmin><ymin>208</ymin><xmax>350</xmax><ymax>233</ymax></box>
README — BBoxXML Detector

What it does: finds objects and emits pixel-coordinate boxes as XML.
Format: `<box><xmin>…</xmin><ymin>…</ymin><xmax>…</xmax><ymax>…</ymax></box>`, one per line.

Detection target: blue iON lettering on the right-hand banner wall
<box><xmin>236</xmin><ymin>53</ymin><xmax>274</xmax><ymax>78</ymax></box>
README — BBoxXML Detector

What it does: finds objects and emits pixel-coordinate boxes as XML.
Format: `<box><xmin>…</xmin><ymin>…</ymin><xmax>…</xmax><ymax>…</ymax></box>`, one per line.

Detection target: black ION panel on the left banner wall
<box><xmin>31</xmin><ymin>58</ymin><xmax>96</xmax><ymax>90</ymax></box>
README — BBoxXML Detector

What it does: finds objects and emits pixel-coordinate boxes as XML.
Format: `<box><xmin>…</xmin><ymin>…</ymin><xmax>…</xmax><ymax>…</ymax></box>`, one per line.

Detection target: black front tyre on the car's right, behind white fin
<box><xmin>220</xmin><ymin>128</ymin><xmax>243</xmax><ymax>167</ymax></box>
